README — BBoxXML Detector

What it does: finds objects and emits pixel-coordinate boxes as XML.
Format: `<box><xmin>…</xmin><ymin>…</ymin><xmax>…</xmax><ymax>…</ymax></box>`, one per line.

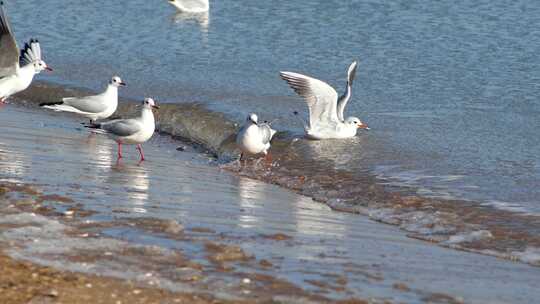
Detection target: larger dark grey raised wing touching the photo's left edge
<box><xmin>0</xmin><ymin>1</ymin><xmax>19</xmax><ymax>78</ymax></box>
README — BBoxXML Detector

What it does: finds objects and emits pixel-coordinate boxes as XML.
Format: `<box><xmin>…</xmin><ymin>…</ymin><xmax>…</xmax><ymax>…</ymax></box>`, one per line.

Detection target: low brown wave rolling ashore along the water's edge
<box><xmin>11</xmin><ymin>83</ymin><xmax>540</xmax><ymax>265</ymax></box>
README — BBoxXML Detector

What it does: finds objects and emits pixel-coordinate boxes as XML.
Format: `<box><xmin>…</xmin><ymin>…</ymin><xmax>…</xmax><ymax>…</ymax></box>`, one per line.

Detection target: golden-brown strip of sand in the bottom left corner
<box><xmin>0</xmin><ymin>254</ymin><xmax>232</xmax><ymax>304</ymax></box>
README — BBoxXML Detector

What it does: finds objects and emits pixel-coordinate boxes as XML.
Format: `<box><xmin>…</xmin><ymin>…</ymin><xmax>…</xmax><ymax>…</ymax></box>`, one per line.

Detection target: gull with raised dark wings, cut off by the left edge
<box><xmin>0</xmin><ymin>1</ymin><xmax>52</xmax><ymax>104</ymax></box>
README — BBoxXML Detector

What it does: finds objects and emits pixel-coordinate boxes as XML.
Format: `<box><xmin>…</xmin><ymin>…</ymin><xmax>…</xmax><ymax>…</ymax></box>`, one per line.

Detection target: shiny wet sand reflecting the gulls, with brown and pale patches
<box><xmin>0</xmin><ymin>105</ymin><xmax>540</xmax><ymax>303</ymax></box>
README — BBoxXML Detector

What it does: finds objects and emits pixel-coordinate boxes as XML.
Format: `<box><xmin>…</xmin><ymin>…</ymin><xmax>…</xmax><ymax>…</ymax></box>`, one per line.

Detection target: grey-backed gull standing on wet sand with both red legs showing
<box><xmin>85</xmin><ymin>98</ymin><xmax>159</xmax><ymax>161</ymax></box>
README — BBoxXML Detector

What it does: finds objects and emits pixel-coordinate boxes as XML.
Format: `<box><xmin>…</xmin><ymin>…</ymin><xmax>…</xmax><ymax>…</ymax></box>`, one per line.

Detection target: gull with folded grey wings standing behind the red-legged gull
<box><xmin>40</xmin><ymin>76</ymin><xmax>126</xmax><ymax>123</ymax></box>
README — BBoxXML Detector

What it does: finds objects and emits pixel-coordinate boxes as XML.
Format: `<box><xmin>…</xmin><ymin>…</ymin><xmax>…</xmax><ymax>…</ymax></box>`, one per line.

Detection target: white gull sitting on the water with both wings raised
<box><xmin>280</xmin><ymin>61</ymin><xmax>369</xmax><ymax>139</ymax></box>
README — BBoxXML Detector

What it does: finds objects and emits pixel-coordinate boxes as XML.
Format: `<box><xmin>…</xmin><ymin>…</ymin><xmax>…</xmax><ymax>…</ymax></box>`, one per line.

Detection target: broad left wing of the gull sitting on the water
<box><xmin>280</xmin><ymin>72</ymin><xmax>339</xmax><ymax>128</ymax></box>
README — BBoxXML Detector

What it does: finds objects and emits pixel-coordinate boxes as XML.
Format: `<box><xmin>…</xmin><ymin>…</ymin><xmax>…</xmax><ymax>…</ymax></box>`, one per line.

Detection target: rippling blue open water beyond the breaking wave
<box><xmin>8</xmin><ymin>0</ymin><xmax>540</xmax><ymax>213</ymax></box>
